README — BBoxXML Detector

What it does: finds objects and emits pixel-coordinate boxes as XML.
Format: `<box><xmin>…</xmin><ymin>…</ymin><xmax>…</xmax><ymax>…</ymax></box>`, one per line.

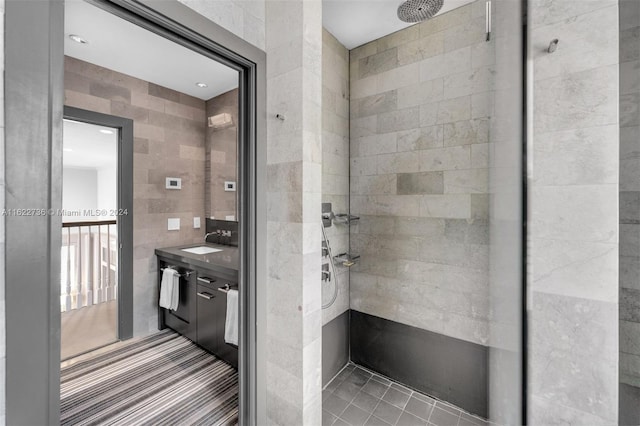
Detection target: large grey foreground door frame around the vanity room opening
<box><xmin>0</xmin><ymin>0</ymin><xmax>267</xmax><ymax>425</ymax></box>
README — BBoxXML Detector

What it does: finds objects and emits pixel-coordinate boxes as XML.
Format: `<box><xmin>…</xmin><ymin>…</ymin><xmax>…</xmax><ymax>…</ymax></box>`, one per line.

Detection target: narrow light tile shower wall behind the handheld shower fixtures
<box><xmin>322</xmin><ymin>29</ymin><xmax>349</xmax><ymax>325</ymax></box>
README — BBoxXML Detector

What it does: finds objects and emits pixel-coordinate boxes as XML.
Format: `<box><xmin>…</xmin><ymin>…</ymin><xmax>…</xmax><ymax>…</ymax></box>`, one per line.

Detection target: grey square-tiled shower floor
<box><xmin>322</xmin><ymin>363</ymin><xmax>487</xmax><ymax>426</ymax></box>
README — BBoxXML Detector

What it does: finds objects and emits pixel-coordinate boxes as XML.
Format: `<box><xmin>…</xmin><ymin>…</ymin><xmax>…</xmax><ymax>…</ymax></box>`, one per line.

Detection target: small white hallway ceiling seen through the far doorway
<box><xmin>62</xmin><ymin>120</ymin><xmax>118</xmax><ymax>169</ymax></box>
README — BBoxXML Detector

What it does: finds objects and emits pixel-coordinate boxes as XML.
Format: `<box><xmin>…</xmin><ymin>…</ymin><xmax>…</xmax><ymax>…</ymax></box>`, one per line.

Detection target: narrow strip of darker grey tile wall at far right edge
<box><xmin>619</xmin><ymin>0</ymin><xmax>640</xmax><ymax>387</ymax></box>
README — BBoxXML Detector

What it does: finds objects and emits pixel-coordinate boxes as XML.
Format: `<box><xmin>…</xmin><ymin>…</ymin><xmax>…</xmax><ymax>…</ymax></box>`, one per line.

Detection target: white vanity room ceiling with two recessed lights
<box><xmin>64</xmin><ymin>0</ymin><xmax>238</xmax><ymax>100</ymax></box>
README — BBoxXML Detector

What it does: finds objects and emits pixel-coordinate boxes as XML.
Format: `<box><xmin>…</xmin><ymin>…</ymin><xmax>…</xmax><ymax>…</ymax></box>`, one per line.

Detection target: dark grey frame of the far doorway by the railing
<box><xmin>63</xmin><ymin>105</ymin><xmax>133</xmax><ymax>340</ymax></box>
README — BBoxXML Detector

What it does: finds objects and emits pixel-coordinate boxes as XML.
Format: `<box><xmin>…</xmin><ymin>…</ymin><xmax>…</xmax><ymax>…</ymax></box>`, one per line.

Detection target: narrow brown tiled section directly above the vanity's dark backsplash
<box><xmin>204</xmin><ymin>89</ymin><xmax>238</xmax><ymax>220</ymax></box>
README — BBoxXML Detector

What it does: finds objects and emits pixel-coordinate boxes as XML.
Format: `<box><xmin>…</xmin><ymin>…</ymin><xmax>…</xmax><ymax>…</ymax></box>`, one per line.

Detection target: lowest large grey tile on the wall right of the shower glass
<box><xmin>531</xmin><ymin>292</ymin><xmax>618</xmax><ymax>424</ymax></box>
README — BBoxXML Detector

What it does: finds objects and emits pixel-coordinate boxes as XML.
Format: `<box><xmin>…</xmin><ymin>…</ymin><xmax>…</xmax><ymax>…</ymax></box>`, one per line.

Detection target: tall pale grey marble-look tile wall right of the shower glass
<box><xmin>529</xmin><ymin>0</ymin><xmax>620</xmax><ymax>425</ymax></box>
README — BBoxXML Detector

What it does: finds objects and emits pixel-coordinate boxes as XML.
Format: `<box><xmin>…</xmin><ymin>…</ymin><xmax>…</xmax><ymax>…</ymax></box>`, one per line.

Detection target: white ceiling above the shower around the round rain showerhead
<box><xmin>322</xmin><ymin>0</ymin><xmax>474</xmax><ymax>49</ymax></box>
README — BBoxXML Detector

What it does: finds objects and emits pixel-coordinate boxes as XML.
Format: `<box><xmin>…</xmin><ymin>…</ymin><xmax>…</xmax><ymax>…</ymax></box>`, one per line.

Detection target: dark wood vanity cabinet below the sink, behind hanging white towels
<box><xmin>158</xmin><ymin>258</ymin><xmax>238</xmax><ymax>368</ymax></box>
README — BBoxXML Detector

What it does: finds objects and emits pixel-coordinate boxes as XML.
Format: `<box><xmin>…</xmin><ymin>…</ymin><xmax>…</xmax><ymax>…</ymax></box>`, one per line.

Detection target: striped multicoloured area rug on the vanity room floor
<box><xmin>60</xmin><ymin>330</ymin><xmax>238</xmax><ymax>426</ymax></box>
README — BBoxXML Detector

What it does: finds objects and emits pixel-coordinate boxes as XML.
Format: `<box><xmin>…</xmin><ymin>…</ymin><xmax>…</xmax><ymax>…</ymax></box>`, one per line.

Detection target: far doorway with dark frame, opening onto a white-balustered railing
<box><xmin>60</xmin><ymin>107</ymin><xmax>133</xmax><ymax>360</ymax></box>
